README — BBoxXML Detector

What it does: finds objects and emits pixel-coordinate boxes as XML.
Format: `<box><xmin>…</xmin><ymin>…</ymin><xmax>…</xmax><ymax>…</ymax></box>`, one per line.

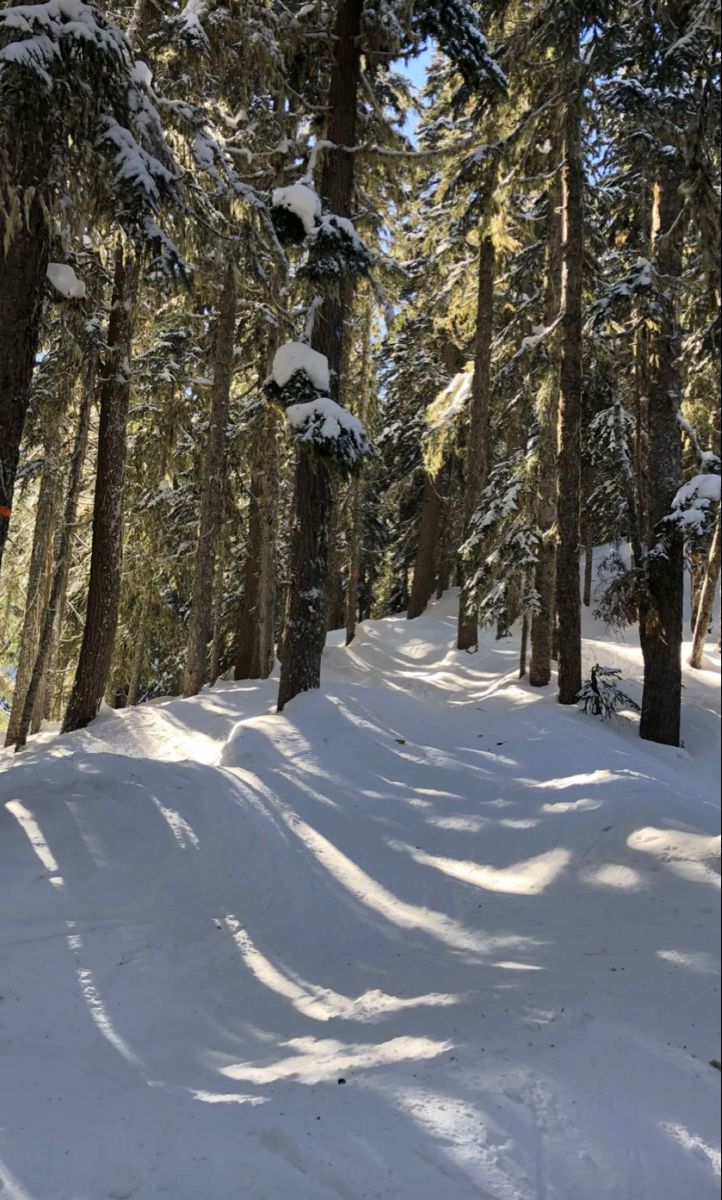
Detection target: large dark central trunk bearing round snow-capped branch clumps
<box><xmin>278</xmin><ymin>0</ymin><xmax>363</xmax><ymax>712</ymax></box>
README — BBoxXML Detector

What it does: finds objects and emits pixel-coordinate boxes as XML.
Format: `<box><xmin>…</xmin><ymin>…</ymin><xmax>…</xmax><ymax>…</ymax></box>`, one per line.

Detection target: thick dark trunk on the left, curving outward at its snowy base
<box><xmin>62</xmin><ymin>246</ymin><xmax>139</xmax><ymax>733</ymax></box>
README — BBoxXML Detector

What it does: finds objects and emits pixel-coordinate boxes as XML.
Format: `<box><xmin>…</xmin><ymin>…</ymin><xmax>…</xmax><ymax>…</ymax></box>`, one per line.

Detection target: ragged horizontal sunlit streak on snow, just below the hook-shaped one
<box><xmin>221</xmin><ymin>1037</ymin><xmax>453</xmax><ymax>1084</ymax></box>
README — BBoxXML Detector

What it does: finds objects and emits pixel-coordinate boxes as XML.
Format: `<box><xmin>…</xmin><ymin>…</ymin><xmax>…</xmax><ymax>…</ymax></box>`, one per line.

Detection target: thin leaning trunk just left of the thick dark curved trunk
<box><xmin>16</xmin><ymin>355</ymin><xmax>95</xmax><ymax>750</ymax></box>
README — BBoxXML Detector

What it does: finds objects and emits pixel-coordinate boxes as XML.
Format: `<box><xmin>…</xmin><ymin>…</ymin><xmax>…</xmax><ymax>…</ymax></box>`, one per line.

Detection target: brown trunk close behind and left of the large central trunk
<box><xmin>235</xmin><ymin>404</ymin><xmax>278</xmax><ymax>679</ymax></box>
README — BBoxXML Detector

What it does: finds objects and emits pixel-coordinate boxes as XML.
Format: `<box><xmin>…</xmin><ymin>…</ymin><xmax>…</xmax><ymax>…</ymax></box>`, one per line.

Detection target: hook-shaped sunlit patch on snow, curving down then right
<box><xmin>225</xmin><ymin>913</ymin><xmax>459</xmax><ymax>1021</ymax></box>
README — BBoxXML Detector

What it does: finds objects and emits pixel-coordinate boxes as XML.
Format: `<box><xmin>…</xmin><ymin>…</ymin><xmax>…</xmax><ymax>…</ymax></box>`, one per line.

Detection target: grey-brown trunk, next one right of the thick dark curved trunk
<box><xmin>183</xmin><ymin>262</ymin><xmax>236</xmax><ymax>696</ymax></box>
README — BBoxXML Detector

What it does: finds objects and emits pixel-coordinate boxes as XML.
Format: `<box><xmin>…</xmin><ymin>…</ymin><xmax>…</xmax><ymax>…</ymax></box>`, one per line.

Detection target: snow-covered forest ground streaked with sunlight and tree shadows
<box><xmin>0</xmin><ymin>585</ymin><xmax>720</xmax><ymax>1200</ymax></box>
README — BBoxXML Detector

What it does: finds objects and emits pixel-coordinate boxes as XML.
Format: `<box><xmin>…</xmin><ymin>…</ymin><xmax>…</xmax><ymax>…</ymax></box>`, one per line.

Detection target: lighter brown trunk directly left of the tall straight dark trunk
<box><xmin>529</xmin><ymin>176</ymin><xmax>561</xmax><ymax>688</ymax></box>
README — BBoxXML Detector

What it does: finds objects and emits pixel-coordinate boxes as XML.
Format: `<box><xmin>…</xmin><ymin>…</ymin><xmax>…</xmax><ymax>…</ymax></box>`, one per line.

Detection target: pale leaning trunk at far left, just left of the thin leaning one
<box><xmin>5</xmin><ymin>406</ymin><xmax>64</xmax><ymax>746</ymax></box>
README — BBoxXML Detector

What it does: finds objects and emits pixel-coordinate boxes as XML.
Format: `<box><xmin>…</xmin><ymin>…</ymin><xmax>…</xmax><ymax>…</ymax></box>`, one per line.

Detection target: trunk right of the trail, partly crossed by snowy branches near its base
<box><xmin>457</xmin><ymin>235</ymin><xmax>497</xmax><ymax>650</ymax></box>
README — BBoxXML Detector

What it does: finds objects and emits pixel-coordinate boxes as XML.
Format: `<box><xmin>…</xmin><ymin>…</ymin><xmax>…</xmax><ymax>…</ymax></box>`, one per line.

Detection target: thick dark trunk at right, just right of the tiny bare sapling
<box><xmin>639</xmin><ymin>177</ymin><xmax>684</xmax><ymax>746</ymax></box>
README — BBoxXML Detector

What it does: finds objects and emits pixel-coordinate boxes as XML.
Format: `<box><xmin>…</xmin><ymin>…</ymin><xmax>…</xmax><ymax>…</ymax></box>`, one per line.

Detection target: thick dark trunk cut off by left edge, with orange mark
<box><xmin>0</xmin><ymin>193</ymin><xmax>49</xmax><ymax>580</ymax></box>
